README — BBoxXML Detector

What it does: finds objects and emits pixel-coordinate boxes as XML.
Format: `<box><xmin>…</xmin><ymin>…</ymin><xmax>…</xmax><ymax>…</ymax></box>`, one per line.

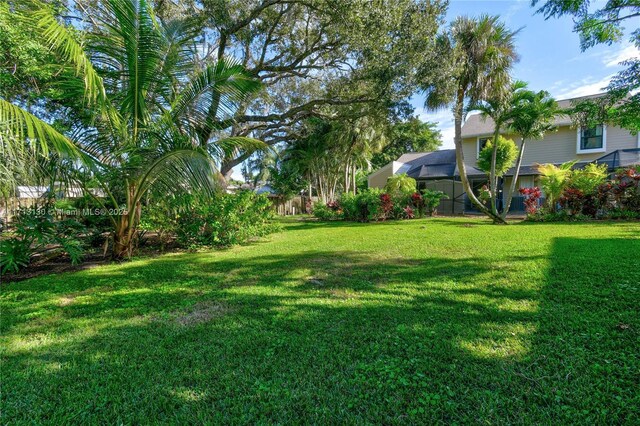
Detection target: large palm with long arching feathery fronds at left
<box><xmin>0</xmin><ymin>0</ymin><xmax>263</xmax><ymax>257</ymax></box>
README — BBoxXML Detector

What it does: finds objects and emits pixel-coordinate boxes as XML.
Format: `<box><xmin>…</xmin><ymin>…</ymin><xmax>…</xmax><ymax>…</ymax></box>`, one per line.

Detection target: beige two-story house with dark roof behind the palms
<box><xmin>369</xmin><ymin>94</ymin><xmax>640</xmax><ymax>213</ymax></box>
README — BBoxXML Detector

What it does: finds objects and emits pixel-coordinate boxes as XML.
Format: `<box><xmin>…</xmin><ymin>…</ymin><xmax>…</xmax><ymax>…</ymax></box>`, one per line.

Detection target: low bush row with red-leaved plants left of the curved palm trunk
<box><xmin>313</xmin><ymin>188</ymin><xmax>446</xmax><ymax>222</ymax></box>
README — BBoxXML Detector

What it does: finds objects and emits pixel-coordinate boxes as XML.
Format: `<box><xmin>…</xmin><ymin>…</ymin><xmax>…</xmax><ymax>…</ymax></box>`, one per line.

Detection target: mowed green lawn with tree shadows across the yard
<box><xmin>1</xmin><ymin>218</ymin><xmax>640</xmax><ymax>424</ymax></box>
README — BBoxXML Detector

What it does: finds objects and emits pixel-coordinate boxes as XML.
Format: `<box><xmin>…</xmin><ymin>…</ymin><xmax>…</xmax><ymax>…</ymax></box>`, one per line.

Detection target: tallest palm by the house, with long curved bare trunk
<box><xmin>423</xmin><ymin>16</ymin><xmax>518</xmax><ymax>223</ymax></box>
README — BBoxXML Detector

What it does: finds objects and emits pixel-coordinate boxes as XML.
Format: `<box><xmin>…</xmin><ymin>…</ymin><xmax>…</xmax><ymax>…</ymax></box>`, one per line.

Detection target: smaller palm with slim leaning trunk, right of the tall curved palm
<box><xmin>501</xmin><ymin>90</ymin><xmax>559</xmax><ymax>219</ymax></box>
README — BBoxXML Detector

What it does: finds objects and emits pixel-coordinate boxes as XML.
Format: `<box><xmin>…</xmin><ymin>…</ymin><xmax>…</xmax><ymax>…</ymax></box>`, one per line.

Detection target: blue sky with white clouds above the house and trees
<box><xmin>412</xmin><ymin>0</ymin><xmax>640</xmax><ymax>148</ymax></box>
